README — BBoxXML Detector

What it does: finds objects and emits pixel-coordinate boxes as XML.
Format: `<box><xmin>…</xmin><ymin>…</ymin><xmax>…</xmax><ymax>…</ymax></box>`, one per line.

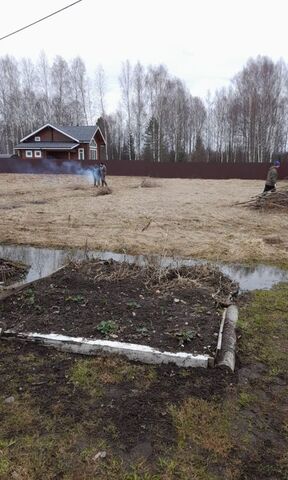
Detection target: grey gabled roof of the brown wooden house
<box><xmin>16</xmin><ymin>123</ymin><xmax>106</xmax><ymax>144</ymax></box>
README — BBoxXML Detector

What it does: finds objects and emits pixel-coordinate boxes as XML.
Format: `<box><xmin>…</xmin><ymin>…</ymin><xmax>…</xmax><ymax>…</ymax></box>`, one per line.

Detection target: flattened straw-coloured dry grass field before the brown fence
<box><xmin>0</xmin><ymin>174</ymin><xmax>288</xmax><ymax>263</ymax></box>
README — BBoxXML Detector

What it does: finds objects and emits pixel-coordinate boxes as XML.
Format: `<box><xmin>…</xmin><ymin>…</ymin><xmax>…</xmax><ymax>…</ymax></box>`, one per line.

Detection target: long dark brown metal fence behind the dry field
<box><xmin>0</xmin><ymin>157</ymin><xmax>288</xmax><ymax>180</ymax></box>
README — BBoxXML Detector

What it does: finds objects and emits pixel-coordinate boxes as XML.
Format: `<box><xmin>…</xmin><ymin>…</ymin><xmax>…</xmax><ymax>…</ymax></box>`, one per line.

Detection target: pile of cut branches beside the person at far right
<box><xmin>236</xmin><ymin>190</ymin><xmax>288</xmax><ymax>211</ymax></box>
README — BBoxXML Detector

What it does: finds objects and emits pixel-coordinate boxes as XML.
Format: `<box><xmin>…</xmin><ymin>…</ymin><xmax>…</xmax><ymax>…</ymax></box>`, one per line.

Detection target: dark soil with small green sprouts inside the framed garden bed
<box><xmin>0</xmin><ymin>261</ymin><xmax>238</xmax><ymax>356</ymax></box>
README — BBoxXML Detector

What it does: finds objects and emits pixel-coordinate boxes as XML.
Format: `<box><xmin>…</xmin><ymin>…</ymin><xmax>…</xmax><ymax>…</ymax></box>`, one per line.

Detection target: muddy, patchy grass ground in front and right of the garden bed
<box><xmin>0</xmin><ymin>285</ymin><xmax>288</xmax><ymax>480</ymax></box>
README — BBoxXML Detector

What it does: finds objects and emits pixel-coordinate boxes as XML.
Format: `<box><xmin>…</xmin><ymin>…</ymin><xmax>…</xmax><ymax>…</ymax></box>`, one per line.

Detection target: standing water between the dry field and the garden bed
<box><xmin>0</xmin><ymin>245</ymin><xmax>288</xmax><ymax>290</ymax></box>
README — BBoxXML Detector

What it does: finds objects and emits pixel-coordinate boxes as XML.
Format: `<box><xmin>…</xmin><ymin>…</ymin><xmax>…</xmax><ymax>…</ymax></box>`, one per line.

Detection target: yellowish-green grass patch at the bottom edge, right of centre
<box><xmin>164</xmin><ymin>397</ymin><xmax>239</xmax><ymax>480</ymax></box>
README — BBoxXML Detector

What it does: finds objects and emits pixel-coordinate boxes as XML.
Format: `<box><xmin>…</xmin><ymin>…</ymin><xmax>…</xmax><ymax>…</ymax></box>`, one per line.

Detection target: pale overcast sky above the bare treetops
<box><xmin>0</xmin><ymin>0</ymin><xmax>288</xmax><ymax>111</ymax></box>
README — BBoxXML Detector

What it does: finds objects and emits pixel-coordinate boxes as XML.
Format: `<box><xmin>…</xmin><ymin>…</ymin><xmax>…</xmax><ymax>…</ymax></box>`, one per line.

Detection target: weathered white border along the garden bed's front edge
<box><xmin>0</xmin><ymin>329</ymin><xmax>214</xmax><ymax>368</ymax></box>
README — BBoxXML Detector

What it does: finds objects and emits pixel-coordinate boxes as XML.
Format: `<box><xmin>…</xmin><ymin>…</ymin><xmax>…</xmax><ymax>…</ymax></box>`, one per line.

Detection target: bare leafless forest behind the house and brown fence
<box><xmin>0</xmin><ymin>53</ymin><xmax>288</xmax><ymax>163</ymax></box>
